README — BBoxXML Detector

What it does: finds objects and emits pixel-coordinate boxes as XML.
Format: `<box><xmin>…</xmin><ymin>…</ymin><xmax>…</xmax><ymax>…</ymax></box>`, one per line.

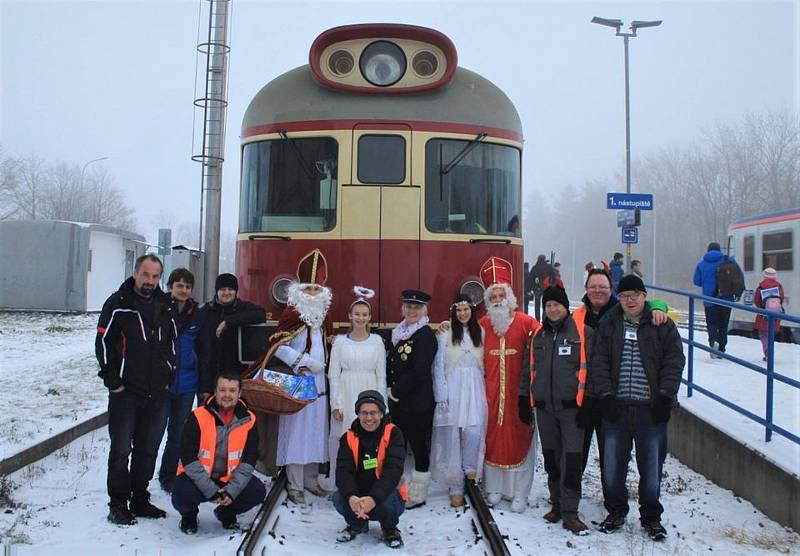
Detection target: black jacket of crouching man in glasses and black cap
<box><xmin>336</xmin><ymin>417</ymin><xmax>406</xmax><ymax>506</ymax></box>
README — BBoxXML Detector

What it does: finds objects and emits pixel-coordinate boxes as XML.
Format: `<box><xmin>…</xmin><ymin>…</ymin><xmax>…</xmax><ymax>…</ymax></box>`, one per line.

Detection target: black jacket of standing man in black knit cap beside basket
<box><xmin>198</xmin><ymin>298</ymin><xmax>267</xmax><ymax>394</ymax></box>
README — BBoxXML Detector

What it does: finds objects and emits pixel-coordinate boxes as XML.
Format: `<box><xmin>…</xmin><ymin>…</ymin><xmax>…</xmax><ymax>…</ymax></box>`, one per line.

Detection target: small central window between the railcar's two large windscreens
<box><xmin>358</xmin><ymin>135</ymin><xmax>406</xmax><ymax>184</ymax></box>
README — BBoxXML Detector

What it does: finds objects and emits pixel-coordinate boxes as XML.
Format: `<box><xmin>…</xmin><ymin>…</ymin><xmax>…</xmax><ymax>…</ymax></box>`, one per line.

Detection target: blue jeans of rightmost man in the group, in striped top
<box><xmin>602</xmin><ymin>405</ymin><xmax>667</xmax><ymax>523</ymax></box>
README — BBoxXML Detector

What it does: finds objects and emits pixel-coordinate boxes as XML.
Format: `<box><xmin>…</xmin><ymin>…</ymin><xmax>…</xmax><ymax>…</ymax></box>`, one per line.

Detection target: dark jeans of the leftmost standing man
<box><xmin>106</xmin><ymin>390</ymin><xmax>163</xmax><ymax>506</ymax></box>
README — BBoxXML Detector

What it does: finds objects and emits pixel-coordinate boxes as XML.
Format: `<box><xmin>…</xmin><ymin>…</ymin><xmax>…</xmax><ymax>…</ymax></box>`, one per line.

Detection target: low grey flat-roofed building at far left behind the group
<box><xmin>0</xmin><ymin>220</ymin><xmax>147</xmax><ymax>311</ymax></box>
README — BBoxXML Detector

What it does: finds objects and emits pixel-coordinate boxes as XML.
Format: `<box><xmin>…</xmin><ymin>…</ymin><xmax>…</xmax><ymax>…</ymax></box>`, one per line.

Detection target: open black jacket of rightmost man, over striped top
<box><xmin>587</xmin><ymin>303</ymin><xmax>686</xmax><ymax>403</ymax></box>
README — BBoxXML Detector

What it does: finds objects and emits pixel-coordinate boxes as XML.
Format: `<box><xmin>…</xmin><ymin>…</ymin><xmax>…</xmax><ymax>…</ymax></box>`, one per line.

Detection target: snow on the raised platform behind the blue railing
<box><xmin>679</xmin><ymin>329</ymin><xmax>800</xmax><ymax>475</ymax></box>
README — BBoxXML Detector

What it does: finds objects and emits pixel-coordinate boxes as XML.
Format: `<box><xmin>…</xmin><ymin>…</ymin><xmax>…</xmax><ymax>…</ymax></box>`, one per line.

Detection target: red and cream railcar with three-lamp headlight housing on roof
<box><xmin>237</xmin><ymin>24</ymin><xmax>522</xmax><ymax>327</ymax></box>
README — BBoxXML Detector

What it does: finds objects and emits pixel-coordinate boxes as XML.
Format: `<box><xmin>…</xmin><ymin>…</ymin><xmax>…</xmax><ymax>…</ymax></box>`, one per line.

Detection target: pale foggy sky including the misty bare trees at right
<box><xmin>0</xmin><ymin>0</ymin><xmax>800</xmax><ymax>289</ymax></box>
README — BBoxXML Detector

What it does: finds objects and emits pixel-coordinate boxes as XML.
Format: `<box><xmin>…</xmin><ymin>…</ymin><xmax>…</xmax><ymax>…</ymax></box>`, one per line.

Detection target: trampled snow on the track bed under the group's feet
<box><xmin>0</xmin><ymin>428</ymin><xmax>800</xmax><ymax>555</ymax></box>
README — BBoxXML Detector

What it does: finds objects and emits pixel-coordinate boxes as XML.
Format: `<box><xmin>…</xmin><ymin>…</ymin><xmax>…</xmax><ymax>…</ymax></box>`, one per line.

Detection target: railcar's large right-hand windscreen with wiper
<box><xmin>425</xmin><ymin>139</ymin><xmax>522</xmax><ymax>237</ymax></box>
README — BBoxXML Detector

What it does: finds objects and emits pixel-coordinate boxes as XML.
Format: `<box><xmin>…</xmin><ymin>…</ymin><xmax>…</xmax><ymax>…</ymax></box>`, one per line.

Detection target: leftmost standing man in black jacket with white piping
<box><xmin>95</xmin><ymin>255</ymin><xmax>177</xmax><ymax>525</ymax></box>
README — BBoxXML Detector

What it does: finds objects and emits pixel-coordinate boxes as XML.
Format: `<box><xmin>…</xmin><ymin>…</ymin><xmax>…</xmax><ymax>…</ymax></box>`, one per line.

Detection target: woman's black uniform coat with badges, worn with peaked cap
<box><xmin>386</xmin><ymin>326</ymin><xmax>439</xmax><ymax>413</ymax></box>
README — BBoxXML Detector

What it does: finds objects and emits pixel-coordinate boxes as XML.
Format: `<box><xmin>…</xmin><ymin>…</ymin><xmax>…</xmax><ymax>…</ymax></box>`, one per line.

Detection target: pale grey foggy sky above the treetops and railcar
<box><xmin>0</xmin><ymin>0</ymin><xmax>800</xmax><ymax>255</ymax></box>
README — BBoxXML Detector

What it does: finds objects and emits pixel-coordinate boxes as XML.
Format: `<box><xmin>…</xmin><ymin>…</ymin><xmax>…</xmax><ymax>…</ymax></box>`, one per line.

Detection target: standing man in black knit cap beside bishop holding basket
<box><xmin>198</xmin><ymin>273</ymin><xmax>267</xmax><ymax>401</ymax></box>
